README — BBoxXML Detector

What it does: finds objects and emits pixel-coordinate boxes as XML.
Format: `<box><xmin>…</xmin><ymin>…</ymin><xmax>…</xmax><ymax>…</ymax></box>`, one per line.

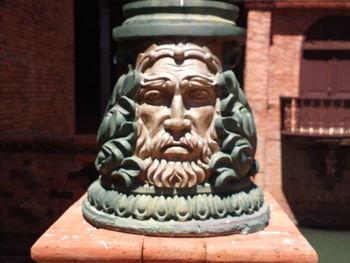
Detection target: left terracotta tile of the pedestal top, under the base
<box><xmin>31</xmin><ymin>193</ymin><xmax>144</xmax><ymax>262</ymax></box>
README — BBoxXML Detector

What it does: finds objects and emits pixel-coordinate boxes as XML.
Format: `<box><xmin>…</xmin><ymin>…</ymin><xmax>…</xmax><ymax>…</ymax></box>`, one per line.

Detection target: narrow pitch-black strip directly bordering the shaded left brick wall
<box><xmin>74</xmin><ymin>0</ymin><xmax>99</xmax><ymax>133</ymax></box>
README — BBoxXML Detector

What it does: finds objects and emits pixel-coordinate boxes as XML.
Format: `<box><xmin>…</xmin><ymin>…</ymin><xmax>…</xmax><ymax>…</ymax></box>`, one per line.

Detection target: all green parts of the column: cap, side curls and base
<box><xmin>83</xmin><ymin>0</ymin><xmax>269</xmax><ymax>236</ymax></box>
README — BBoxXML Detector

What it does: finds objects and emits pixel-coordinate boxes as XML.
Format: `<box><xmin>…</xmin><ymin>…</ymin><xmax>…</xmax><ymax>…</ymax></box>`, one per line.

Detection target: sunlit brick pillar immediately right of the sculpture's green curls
<box><xmin>244</xmin><ymin>10</ymin><xmax>271</xmax><ymax>187</ymax></box>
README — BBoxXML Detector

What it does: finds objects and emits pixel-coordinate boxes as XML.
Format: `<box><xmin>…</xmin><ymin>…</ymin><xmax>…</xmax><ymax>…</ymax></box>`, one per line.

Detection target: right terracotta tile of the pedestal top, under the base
<box><xmin>206</xmin><ymin>192</ymin><xmax>317</xmax><ymax>263</ymax></box>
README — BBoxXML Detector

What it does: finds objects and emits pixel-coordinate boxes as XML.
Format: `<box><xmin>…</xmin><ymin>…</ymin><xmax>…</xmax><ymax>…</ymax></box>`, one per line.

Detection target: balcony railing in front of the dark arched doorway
<box><xmin>281</xmin><ymin>97</ymin><xmax>350</xmax><ymax>137</ymax></box>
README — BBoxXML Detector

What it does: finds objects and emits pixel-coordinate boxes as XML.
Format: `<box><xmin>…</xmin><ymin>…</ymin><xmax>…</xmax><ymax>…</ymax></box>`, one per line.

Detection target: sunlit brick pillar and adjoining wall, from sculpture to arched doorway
<box><xmin>244</xmin><ymin>9</ymin><xmax>301</xmax><ymax>216</ymax></box>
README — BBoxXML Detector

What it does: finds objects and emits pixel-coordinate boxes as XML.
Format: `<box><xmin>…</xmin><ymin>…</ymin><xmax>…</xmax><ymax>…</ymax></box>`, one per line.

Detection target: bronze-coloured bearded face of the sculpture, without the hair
<box><xmin>135</xmin><ymin>46</ymin><xmax>219</xmax><ymax>188</ymax></box>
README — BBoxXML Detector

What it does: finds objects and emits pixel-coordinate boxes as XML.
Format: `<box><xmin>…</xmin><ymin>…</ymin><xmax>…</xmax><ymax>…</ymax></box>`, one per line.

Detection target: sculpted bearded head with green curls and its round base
<box><xmin>83</xmin><ymin>42</ymin><xmax>268</xmax><ymax>235</ymax></box>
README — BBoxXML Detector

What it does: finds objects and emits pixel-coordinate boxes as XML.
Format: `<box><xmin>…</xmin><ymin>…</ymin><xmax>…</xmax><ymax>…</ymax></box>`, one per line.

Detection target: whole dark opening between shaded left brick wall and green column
<box><xmin>74</xmin><ymin>0</ymin><xmax>124</xmax><ymax>134</ymax></box>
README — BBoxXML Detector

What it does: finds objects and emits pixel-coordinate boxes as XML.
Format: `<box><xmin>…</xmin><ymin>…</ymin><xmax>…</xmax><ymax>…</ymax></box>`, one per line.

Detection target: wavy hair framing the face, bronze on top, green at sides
<box><xmin>95</xmin><ymin>44</ymin><xmax>258</xmax><ymax>187</ymax></box>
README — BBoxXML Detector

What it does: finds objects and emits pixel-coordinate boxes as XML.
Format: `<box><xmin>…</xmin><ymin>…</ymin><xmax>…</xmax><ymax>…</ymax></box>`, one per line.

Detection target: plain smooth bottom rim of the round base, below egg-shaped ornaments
<box><xmin>82</xmin><ymin>199</ymin><xmax>270</xmax><ymax>237</ymax></box>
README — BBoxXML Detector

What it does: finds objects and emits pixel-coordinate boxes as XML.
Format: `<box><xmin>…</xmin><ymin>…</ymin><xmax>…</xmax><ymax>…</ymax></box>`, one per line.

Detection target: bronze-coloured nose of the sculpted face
<box><xmin>164</xmin><ymin>95</ymin><xmax>191</xmax><ymax>140</ymax></box>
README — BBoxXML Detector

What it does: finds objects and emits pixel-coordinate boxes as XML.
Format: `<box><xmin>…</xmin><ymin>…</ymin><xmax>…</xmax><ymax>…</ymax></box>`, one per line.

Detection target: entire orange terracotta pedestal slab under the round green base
<box><xmin>31</xmin><ymin>193</ymin><xmax>317</xmax><ymax>263</ymax></box>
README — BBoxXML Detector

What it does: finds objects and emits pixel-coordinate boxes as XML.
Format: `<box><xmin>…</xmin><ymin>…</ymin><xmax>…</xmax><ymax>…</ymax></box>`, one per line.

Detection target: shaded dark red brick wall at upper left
<box><xmin>0</xmin><ymin>0</ymin><xmax>75</xmax><ymax>134</ymax></box>
